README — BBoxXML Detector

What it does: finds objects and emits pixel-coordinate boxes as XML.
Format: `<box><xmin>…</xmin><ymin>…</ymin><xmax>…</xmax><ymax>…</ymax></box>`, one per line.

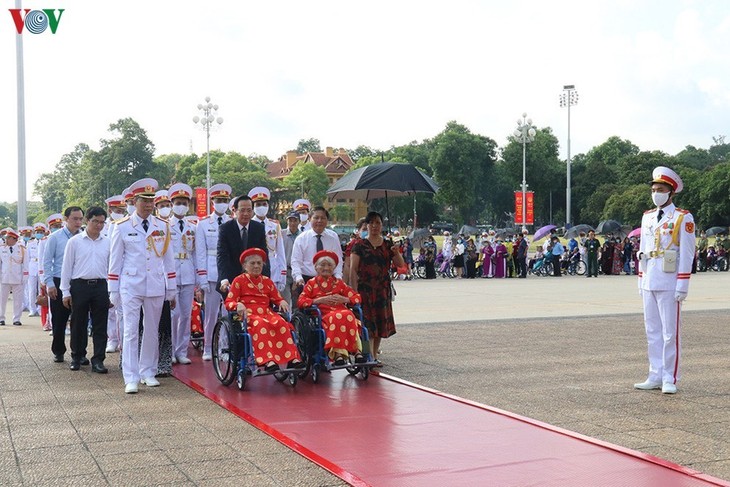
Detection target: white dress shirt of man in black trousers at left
<box><xmin>61</xmin><ymin>231</ymin><xmax>111</xmax><ymax>296</ymax></box>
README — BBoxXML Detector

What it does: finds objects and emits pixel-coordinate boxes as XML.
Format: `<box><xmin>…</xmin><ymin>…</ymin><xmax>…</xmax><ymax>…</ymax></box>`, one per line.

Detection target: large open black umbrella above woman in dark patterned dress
<box><xmin>327</xmin><ymin>162</ymin><xmax>438</xmax><ymax>227</ymax></box>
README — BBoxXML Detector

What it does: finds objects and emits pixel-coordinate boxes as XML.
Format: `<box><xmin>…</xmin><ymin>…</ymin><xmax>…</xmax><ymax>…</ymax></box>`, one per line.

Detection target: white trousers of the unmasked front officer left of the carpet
<box><xmin>122</xmin><ymin>293</ymin><xmax>165</xmax><ymax>384</ymax></box>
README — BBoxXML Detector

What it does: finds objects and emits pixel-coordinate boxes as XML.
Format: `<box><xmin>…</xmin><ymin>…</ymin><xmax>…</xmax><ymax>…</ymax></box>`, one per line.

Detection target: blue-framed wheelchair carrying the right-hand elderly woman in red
<box><xmin>292</xmin><ymin>305</ymin><xmax>378</xmax><ymax>384</ymax></box>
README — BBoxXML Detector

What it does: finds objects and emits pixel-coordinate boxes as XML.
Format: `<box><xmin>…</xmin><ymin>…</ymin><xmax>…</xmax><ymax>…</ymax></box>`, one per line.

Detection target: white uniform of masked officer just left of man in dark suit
<box><xmin>195</xmin><ymin>212</ymin><xmax>231</xmax><ymax>354</ymax></box>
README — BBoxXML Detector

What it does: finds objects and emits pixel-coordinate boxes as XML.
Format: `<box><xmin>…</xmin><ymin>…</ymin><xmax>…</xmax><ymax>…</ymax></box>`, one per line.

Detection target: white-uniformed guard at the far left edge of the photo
<box><xmin>0</xmin><ymin>228</ymin><xmax>28</xmax><ymax>326</ymax></box>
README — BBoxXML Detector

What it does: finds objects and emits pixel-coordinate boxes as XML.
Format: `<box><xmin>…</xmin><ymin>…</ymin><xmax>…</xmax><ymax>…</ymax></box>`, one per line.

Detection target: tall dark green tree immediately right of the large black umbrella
<box><xmin>429</xmin><ymin>121</ymin><xmax>496</xmax><ymax>222</ymax></box>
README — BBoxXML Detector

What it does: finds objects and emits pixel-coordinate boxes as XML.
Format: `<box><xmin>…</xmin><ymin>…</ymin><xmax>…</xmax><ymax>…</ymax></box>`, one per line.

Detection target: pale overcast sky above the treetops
<box><xmin>0</xmin><ymin>0</ymin><xmax>730</xmax><ymax>201</ymax></box>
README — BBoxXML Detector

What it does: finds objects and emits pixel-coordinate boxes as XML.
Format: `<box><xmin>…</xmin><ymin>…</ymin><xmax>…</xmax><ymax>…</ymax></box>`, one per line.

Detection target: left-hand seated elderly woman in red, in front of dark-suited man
<box><xmin>225</xmin><ymin>248</ymin><xmax>304</xmax><ymax>372</ymax></box>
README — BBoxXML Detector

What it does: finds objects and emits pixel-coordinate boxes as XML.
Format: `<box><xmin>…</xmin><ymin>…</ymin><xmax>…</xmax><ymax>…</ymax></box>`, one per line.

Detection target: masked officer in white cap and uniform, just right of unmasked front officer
<box><xmin>167</xmin><ymin>183</ymin><xmax>197</xmax><ymax>364</ymax></box>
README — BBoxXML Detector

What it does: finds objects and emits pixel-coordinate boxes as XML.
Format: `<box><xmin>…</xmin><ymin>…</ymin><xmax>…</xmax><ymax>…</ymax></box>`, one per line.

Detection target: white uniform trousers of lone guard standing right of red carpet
<box><xmin>642</xmin><ymin>290</ymin><xmax>682</xmax><ymax>384</ymax></box>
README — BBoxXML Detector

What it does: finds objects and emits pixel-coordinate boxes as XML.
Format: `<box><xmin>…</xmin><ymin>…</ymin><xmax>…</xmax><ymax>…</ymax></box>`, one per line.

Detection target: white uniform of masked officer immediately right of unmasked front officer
<box><xmin>170</xmin><ymin>216</ymin><xmax>195</xmax><ymax>359</ymax></box>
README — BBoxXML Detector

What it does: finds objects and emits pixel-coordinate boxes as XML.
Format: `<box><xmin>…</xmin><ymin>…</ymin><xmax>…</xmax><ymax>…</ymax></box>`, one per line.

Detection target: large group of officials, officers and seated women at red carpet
<box><xmin>0</xmin><ymin>178</ymin><xmax>398</xmax><ymax>394</ymax></box>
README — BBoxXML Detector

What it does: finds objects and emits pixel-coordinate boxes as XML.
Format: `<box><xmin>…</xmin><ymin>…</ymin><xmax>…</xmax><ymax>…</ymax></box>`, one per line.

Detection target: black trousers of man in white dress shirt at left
<box><xmin>69</xmin><ymin>279</ymin><xmax>109</xmax><ymax>364</ymax></box>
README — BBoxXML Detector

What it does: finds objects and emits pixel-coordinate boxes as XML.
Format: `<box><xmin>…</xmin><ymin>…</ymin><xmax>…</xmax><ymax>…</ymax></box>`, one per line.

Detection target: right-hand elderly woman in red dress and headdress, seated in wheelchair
<box><xmin>297</xmin><ymin>250</ymin><xmax>366</xmax><ymax>367</ymax></box>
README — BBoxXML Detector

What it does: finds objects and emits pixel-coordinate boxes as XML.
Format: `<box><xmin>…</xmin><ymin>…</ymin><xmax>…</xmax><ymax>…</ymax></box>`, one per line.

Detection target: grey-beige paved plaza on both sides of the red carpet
<box><xmin>0</xmin><ymin>273</ymin><xmax>730</xmax><ymax>486</ymax></box>
